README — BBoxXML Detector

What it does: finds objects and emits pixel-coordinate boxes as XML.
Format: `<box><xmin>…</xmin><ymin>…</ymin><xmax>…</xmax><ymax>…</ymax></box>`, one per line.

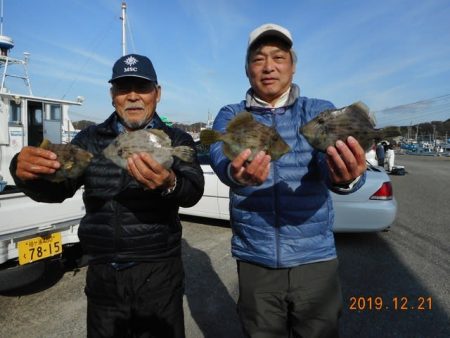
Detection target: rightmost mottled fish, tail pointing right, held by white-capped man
<box><xmin>300</xmin><ymin>101</ymin><xmax>400</xmax><ymax>152</ymax></box>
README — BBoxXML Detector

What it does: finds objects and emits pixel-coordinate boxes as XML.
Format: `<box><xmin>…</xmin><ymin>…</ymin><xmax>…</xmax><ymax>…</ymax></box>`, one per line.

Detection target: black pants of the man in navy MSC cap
<box><xmin>85</xmin><ymin>257</ymin><xmax>185</xmax><ymax>338</ymax></box>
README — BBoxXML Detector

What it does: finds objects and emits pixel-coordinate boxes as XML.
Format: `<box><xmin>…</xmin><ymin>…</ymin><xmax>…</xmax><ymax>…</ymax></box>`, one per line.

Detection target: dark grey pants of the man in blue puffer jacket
<box><xmin>238</xmin><ymin>259</ymin><xmax>342</xmax><ymax>338</ymax></box>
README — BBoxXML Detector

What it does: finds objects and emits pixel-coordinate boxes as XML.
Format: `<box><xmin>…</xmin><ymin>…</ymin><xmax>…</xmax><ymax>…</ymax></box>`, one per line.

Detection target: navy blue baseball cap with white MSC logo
<box><xmin>108</xmin><ymin>54</ymin><xmax>158</xmax><ymax>83</ymax></box>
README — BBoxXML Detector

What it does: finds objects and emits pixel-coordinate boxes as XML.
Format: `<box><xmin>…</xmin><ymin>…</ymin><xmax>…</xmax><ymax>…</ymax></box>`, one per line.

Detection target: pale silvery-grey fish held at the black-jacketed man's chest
<box><xmin>103</xmin><ymin>129</ymin><xmax>194</xmax><ymax>169</ymax></box>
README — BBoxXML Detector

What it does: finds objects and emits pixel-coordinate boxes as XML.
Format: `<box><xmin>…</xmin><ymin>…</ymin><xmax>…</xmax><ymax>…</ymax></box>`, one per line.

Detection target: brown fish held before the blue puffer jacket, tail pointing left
<box><xmin>200</xmin><ymin>111</ymin><xmax>290</xmax><ymax>161</ymax></box>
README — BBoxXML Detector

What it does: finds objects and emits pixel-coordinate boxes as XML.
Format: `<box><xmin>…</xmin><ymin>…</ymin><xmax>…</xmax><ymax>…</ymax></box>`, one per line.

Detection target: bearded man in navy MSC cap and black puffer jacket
<box><xmin>10</xmin><ymin>54</ymin><xmax>204</xmax><ymax>338</ymax></box>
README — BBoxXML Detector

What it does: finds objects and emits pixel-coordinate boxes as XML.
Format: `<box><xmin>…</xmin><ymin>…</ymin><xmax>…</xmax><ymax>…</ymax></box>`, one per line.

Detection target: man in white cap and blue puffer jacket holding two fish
<box><xmin>210</xmin><ymin>24</ymin><xmax>366</xmax><ymax>338</ymax></box>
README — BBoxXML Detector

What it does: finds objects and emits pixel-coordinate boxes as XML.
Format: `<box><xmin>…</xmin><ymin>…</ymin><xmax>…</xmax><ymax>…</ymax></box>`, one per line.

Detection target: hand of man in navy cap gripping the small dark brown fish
<box><xmin>16</xmin><ymin>147</ymin><xmax>61</xmax><ymax>181</ymax></box>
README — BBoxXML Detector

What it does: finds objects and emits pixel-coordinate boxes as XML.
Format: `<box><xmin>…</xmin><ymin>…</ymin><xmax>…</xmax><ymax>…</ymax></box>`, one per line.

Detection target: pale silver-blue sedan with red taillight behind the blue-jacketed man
<box><xmin>180</xmin><ymin>145</ymin><xmax>397</xmax><ymax>232</ymax></box>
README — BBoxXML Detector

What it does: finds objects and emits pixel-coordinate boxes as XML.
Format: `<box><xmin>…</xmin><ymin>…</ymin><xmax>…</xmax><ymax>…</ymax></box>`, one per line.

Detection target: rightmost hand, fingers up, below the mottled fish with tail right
<box><xmin>327</xmin><ymin>136</ymin><xmax>367</xmax><ymax>184</ymax></box>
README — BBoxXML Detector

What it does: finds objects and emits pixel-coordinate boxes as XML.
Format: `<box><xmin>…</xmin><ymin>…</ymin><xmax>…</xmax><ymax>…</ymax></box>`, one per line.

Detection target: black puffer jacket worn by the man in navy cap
<box><xmin>11</xmin><ymin>113</ymin><xmax>204</xmax><ymax>262</ymax></box>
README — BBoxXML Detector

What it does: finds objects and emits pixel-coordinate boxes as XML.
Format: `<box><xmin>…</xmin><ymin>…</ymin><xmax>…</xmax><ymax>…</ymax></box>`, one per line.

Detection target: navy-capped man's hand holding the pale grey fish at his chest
<box><xmin>128</xmin><ymin>153</ymin><xmax>175</xmax><ymax>190</ymax></box>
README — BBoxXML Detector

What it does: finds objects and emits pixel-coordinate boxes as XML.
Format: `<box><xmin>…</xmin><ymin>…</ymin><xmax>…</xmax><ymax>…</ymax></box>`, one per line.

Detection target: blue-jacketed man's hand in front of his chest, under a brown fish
<box><xmin>231</xmin><ymin>149</ymin><xmax>270</xmax><ymax>185</ymax></box>
